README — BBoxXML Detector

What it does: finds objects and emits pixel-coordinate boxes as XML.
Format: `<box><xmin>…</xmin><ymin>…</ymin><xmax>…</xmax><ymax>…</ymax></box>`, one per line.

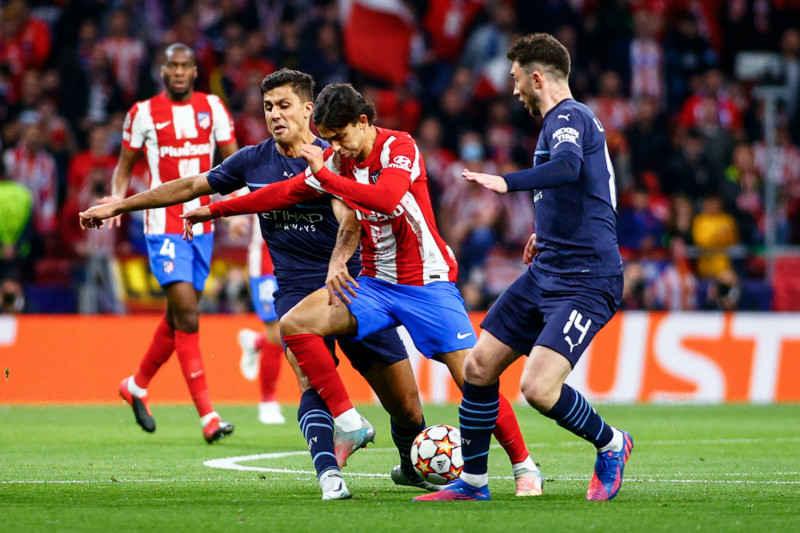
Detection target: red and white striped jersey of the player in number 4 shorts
<box><xmin>122</xmin><ymin>92</ymin><xmax>236</xmax><ymax>235</ymax></box>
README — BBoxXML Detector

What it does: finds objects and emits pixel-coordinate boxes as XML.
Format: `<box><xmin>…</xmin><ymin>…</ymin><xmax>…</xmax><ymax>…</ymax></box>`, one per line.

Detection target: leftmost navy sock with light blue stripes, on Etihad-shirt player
<box><xmin>297</xmin><ymin>389</ymin><xmax>338</xmax><ymax>477</ymax></box>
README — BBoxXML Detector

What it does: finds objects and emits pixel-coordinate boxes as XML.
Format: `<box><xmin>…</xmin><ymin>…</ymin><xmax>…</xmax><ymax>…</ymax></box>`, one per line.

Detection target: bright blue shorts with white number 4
<box><xmin>147</xmin><ymin>233</ymin><xmax>214</xmax><ymax>291</ymax></box>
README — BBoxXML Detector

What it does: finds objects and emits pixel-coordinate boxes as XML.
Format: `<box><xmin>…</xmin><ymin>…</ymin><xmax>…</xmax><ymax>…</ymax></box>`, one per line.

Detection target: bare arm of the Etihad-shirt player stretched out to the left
<box><xmin>78</xmin><ymin>173</ymin><xmax>214</xmax><ymax>229</ymax></box>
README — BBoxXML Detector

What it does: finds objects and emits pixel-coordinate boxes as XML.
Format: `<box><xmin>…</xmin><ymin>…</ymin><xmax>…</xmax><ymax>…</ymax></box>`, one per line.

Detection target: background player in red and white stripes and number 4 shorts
<box><xmin>81</xmin><ymin>43</ymin><xmax>238</xmax><ymax>443</ymax></box>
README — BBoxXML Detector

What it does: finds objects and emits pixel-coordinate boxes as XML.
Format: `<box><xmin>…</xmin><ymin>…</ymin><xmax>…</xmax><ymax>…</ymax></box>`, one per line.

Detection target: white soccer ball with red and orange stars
<box><xmin>411</xmin><ymin>424</ymin><xmax>464</xmax><ymax>485</ymax></box>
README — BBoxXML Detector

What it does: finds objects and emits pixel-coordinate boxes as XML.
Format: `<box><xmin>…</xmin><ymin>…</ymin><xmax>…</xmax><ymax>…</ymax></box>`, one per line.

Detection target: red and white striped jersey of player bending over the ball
<box><xmin>306</xmin><ymin>128</ymin><xmax>458</xmax><ymax>285</ymax></box>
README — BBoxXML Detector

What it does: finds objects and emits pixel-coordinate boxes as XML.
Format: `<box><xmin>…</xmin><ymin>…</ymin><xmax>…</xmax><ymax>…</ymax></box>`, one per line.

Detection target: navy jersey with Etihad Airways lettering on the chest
<box><xmin>208</xmin><ymin>138</ymin><xmax>361</xmax><ymax>288</ymax></box>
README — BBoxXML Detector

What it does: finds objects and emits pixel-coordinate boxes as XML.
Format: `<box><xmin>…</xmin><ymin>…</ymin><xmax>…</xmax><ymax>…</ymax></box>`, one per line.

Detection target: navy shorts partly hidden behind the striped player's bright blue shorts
<box><xmin>275</xmin><ymin>280</ymin><xmax>408</xmax><ymax>375</ymax></box>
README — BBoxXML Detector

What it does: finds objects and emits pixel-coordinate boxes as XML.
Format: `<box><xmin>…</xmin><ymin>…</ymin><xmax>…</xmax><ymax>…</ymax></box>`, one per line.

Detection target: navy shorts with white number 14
<box><xmin>481</xmin><ymin>267</ymin><xmax>622</xmax><ymax>367</ymax></box>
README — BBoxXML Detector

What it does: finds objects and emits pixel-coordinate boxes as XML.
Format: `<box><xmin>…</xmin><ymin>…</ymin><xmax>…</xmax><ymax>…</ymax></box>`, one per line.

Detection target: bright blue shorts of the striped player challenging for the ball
<box><xmin>348</xmin><ymin>276</ymin><xmax>475</xmax><ymax>358</ymax></box>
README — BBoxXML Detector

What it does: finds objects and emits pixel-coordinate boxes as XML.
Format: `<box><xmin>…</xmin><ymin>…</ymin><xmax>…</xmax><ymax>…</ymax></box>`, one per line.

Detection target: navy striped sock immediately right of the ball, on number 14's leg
<box><xmin>458</xmin><ymin>381</ymin><xmax>500</xmax><ymax>475</ymax></box>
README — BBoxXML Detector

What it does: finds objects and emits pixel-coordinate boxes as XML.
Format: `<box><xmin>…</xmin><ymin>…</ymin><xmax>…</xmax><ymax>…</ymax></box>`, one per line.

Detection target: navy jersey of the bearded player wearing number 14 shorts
<box><xmin>533</xmin><ymin>98</ymin><xmax>622</xmax><ymax>277</ymax></box>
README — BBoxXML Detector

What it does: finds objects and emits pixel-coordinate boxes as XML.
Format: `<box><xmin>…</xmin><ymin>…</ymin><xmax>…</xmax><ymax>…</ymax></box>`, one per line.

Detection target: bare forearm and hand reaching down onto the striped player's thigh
<box><xmin>325</xmin><ymin>198</ymin><xmax>361</xmax><ymax>307</ymax></box>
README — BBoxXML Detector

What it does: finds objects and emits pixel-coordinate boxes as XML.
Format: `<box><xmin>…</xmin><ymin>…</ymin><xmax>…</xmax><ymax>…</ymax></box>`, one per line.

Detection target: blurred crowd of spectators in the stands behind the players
<box><xmin>0</xmin><ymin>0</ymin><xmax>800</xmax><ymax>313</ymax></box>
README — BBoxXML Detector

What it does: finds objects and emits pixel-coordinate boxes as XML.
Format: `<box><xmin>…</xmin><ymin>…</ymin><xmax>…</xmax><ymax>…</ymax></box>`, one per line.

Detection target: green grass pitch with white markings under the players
<box><xmin>0</xmin><ymin>404</ymin><xmax>800</xmax><ymax>533</ymax></box>
